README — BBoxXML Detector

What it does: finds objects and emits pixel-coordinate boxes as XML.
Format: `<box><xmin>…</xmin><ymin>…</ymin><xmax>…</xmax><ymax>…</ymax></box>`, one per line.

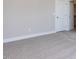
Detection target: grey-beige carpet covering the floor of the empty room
<box><xmin>3</xmin><ymin>31</ymin><xmax>76</xmax><ymax>59</ymax></box>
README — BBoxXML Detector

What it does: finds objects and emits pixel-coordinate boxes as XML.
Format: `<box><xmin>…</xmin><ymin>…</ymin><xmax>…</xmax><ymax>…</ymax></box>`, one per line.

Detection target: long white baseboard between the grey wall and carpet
<box><xmin>3</xmin><ymin>31</ymin><xmax>56</xmax><ymax>43</ymax></box>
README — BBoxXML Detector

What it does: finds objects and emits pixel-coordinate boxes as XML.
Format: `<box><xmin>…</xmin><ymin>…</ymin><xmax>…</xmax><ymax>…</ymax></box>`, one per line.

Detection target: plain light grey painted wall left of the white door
<box><xmin>3</xmin><ymin>0</ymin><xmax>55</xmax><ymax>40</ymax></box>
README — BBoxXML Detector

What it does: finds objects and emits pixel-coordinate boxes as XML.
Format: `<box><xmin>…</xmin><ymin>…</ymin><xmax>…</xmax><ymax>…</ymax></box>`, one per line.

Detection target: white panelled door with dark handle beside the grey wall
<box><xmin>55</xmin><ymin>0</ymin><xmax>69</xmax><ymax>32</ymax></box>
